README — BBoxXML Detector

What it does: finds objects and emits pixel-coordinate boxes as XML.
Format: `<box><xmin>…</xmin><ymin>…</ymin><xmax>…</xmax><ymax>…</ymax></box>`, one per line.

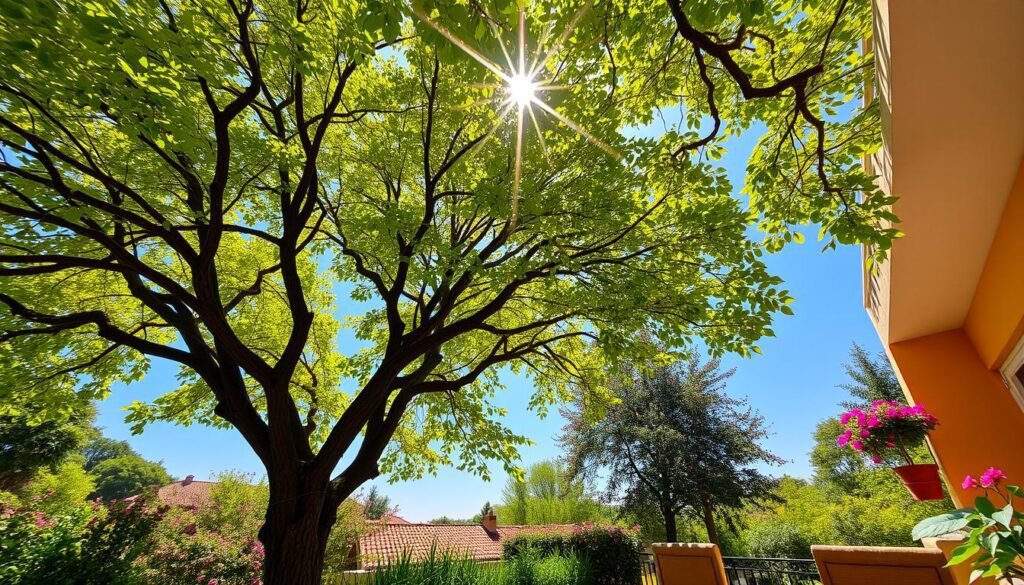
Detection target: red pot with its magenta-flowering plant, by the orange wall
<box><xmin>836</xmin><ymin>401</ymin><xmax>943</xmax><ymax>500</ymax></box>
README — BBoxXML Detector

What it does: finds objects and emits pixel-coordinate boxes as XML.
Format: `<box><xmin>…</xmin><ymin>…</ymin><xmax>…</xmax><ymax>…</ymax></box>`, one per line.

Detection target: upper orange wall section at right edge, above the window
<box><xmin>964</xmin><ymin>160</ymin><xmax>1024</xmax><ymax>369</ymax></box>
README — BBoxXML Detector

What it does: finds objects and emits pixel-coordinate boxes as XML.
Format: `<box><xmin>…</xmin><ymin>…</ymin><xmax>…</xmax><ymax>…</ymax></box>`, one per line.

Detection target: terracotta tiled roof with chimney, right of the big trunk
<box><xmin>359</xmin><ymin>523</ymin><xmax>572</xmax><ymax>569</ymax></box>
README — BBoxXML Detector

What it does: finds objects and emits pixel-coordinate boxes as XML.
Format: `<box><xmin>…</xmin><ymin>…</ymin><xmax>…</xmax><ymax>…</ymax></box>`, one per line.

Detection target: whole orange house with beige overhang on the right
<box><xmin>864</xmin><ymin>0</ymin><xmax>1024</xmax><ymax>505</ymax></box>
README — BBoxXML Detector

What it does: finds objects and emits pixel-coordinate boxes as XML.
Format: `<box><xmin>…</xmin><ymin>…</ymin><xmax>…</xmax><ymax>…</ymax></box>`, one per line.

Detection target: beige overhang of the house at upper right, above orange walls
<box><xmin>865</xmin><ymin>0</ymin><xmax>1024</xmax><ymax>343</ymax></box>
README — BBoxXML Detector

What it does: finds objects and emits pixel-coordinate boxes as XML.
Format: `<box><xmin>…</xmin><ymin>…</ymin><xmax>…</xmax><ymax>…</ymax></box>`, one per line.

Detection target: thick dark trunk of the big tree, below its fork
<box><xmin>259</xmin><ymin>471</ymin><xmax>338</xmax><ymax>585</ymax></box>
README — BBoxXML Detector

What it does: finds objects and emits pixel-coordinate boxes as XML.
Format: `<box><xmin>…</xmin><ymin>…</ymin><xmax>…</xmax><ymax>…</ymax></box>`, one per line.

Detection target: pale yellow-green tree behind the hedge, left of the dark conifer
<box><xmin>497</xmin><ymin>460</ymin><xmax>606</xmax><ymax>525</ymax></box>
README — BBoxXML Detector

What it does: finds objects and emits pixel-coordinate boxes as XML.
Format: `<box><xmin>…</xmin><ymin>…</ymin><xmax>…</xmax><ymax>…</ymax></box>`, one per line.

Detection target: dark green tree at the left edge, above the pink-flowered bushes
<box><xmin>0</xmin><ymin>406</ymin><xmax>95</xmax><ymax>492</ymax></box>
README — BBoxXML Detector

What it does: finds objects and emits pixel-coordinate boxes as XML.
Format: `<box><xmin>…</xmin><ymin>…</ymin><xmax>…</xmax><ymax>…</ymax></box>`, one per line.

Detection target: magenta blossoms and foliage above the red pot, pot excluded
<box><xmin>836</xmin><ymin>401</ymin><xmax>939</xmax><ymax>465</ymax></box>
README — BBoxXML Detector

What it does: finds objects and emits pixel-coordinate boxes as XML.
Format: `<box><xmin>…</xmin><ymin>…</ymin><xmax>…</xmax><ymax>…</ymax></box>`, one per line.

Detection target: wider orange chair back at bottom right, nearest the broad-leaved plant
<box><xmin>811</xmin><ymin>546</ymin><xmax>956</xmax><ymax>585</ymax></box>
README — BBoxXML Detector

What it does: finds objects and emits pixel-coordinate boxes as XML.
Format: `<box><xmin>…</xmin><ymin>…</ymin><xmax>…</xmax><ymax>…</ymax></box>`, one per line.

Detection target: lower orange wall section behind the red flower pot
<box><xmin>889</xmin><ymin>329</ymin><xmax>1024</xmax><ymax>505</ymax></box>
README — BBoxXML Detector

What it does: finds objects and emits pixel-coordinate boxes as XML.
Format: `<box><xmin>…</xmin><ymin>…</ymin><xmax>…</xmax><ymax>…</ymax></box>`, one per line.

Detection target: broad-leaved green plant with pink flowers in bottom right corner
<box><xmin>911</xmin><ymin>467</ymin><xmax>1024</xmax><ymax>583</ymax></box>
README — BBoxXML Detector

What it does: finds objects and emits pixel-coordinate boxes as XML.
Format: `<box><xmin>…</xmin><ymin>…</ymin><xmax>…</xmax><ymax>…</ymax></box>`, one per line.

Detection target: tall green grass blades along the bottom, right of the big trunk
<box><xmin>334</xmin><ymin>549</ymin><xmax>592</xmax><ymax>585</ymax></box>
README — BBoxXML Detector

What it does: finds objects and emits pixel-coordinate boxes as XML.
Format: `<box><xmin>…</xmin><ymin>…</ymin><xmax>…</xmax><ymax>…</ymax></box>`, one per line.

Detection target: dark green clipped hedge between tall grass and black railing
<box><xmin>502</xmin><ymin>526</ymin><xmax>642</xmax><ymax>585</ymax></box>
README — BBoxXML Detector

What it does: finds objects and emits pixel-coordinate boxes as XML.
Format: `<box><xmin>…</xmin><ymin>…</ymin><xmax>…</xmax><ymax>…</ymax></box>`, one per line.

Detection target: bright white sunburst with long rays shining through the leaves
<box><xmin>414</xmin><ymin>6</ymin><xmax>622</xmax><ymax>225</ymax></box>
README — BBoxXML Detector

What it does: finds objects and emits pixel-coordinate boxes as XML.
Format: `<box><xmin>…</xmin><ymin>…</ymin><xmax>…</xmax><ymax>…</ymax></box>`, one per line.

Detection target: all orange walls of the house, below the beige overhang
<box><xmin>889</xmin><ymin>160</ymin><xmax>1024</xmax><ymax>504</ymax></box>
